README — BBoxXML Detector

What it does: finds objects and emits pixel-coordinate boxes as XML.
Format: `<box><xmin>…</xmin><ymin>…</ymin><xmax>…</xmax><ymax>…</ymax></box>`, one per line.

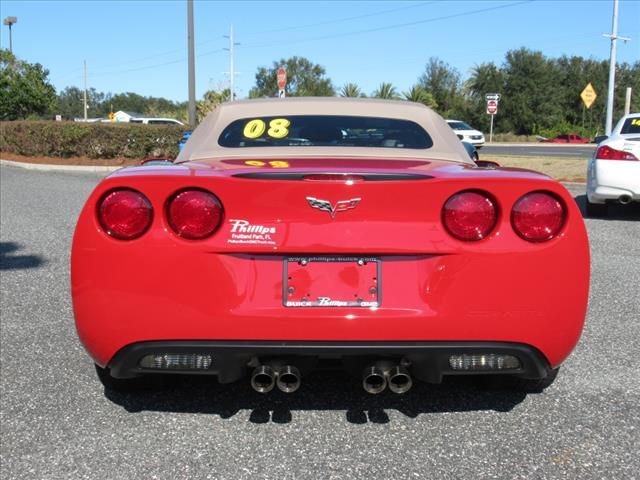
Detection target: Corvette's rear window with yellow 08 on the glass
<box><xmin>218</xmin><ymin>115</ymin><xmax>433</xmax><ymax>149</ymax></box>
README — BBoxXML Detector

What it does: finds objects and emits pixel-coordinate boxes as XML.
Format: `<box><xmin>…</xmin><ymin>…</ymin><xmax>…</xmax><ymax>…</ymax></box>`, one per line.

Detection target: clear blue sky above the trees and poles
<box><xmin>1</xmin><ymin>0</ymin><xmax>640</xmax><ymax>100</ymax></box>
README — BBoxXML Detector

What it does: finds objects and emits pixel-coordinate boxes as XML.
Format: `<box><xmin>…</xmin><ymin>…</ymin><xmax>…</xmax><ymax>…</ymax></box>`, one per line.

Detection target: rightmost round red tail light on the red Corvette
<box><xmin>511</xmin><ymin>192</ymin><xmax>567</xmax><ymax>242</ymax></box>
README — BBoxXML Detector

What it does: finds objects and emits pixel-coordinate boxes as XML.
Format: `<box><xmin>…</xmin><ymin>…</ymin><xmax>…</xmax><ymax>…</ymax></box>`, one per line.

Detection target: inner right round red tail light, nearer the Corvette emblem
<box><xmin>442</xmin><ymin>191</ymin><xmax>498</xmax><ymax>242</ymax></box>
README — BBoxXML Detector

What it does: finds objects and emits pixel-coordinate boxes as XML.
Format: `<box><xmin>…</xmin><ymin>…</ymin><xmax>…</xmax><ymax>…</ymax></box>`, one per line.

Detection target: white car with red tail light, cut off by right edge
<box><xmin>587</xmin><ymin>113</ymin><xmax>640</xmax><ymax>217</ymax></box>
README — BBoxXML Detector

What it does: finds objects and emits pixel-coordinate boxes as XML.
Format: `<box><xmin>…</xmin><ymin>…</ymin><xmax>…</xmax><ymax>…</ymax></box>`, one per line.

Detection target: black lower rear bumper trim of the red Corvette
<box><xmin>108</xmin><ymin>341</ymin><xmax>551</xmax><ymax>383</ymax></box>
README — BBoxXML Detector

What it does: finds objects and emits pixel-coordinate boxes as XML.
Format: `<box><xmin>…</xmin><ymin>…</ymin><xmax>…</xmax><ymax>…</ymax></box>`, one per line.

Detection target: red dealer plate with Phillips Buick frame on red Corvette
<box><xmin>283</xmin><ymin>257</ymin><xmax>382</xmax><ymax>307</ymax></box>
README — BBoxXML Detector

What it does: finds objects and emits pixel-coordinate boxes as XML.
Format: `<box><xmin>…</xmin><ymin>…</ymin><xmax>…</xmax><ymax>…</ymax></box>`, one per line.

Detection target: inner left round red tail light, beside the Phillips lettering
<box><xmin>167</xmin><ymin>190</ymin><xmax>223</xmax><ymax>240</ymax></box>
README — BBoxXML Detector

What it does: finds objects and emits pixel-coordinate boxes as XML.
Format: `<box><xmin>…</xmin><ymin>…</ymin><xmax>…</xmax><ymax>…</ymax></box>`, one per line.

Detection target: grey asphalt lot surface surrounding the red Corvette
<box><xmin>0</xmin><ymin>166</ymin><xmax>640</xmax><ymax>480</ymax></box>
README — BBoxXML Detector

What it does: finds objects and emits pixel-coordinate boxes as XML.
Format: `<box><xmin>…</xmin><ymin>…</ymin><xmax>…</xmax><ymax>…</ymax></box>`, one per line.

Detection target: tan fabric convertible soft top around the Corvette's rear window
<box><xmin>177</xmin><ymin>97</ymin><xmax>473</xmax><ymax>163</ymax></box>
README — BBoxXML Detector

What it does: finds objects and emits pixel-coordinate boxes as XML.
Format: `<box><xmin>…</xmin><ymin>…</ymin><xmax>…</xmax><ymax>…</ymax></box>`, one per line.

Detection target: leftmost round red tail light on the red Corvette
<box><xmin>98</xmin><ymin>188</ymin><xmax>153</xmax><ymax>240</ymax></box>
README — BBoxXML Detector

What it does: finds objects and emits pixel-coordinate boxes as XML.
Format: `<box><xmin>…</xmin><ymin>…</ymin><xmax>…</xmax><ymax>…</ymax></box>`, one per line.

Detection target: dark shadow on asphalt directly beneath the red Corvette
<box><xmin>105</xmin><ymin>371</ymin><xmax>526</xmax><ymax>424</ymax></box>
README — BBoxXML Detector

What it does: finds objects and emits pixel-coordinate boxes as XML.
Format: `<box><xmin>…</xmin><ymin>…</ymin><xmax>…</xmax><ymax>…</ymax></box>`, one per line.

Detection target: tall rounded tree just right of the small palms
<box><xmin>418</xmin><ymin>57</ymin><xmax>465</xmax><ymax>117</ymax></box>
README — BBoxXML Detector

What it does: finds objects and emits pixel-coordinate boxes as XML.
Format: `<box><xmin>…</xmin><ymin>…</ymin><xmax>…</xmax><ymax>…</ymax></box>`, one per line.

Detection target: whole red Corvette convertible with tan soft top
<box><xmin>71</xmin><ymin>98</ymin><xmax>589</xmax><ymax>393</ymax></box>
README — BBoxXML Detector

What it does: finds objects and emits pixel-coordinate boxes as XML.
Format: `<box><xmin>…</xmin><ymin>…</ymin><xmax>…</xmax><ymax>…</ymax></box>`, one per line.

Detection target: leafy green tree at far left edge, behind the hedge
<box><xmin>0</xmin><ymin>50</ymin><xmax>56</xmax><ymax>120</ymax></box>
